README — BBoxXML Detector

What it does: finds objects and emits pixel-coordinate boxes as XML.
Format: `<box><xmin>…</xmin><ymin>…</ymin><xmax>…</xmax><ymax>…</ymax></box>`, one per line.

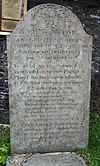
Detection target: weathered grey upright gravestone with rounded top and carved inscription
<box><xmin>7</xmin><ymin>4</ymin><xmax>92</xmax><ymax>154</ymax></box>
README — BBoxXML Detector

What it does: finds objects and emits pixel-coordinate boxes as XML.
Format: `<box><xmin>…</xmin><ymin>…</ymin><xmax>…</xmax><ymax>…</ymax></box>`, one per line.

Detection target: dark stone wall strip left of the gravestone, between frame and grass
<box><xmin>0</xmin><ymin>36</ymin><xmax>9</xmax><ymax>123</ymax></box>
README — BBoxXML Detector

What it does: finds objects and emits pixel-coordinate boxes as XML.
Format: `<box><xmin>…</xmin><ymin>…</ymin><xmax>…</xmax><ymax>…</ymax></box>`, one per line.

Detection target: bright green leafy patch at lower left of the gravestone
<box><xmin>0</xmin><ymin>126</ymin><xmax>10</xmax><ymax>164</ymax></box>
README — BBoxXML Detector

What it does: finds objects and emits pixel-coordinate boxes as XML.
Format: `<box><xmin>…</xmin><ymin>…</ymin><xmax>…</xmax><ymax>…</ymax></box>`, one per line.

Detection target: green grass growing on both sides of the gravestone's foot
<box><xmin>0</xmin><ymin>110</ymin><xmax>100</xmax><ymax>166</ymax></box>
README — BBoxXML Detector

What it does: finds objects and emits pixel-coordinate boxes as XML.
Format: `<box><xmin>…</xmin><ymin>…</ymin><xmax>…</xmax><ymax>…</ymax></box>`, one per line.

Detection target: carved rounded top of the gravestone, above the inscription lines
<box><xmin>12</xmin><ymin>3</ymin><xmax>89</xmax><ymax>36</ymax></box>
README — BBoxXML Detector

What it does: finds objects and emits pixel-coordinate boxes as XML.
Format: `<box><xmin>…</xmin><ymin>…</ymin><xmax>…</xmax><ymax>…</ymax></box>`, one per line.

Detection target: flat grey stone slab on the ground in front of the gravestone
<box><xmin>6</xmin><ymin>152</ymin><xmax>87</xmax><ymax>166</ymax></box>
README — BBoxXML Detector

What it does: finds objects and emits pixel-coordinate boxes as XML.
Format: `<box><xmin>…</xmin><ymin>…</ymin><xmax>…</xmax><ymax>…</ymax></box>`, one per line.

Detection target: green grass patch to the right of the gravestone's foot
<box><xmin>76</xmin><ymin>110</ymin><xmax>100</xmax><ymax>166</ymax></box>
